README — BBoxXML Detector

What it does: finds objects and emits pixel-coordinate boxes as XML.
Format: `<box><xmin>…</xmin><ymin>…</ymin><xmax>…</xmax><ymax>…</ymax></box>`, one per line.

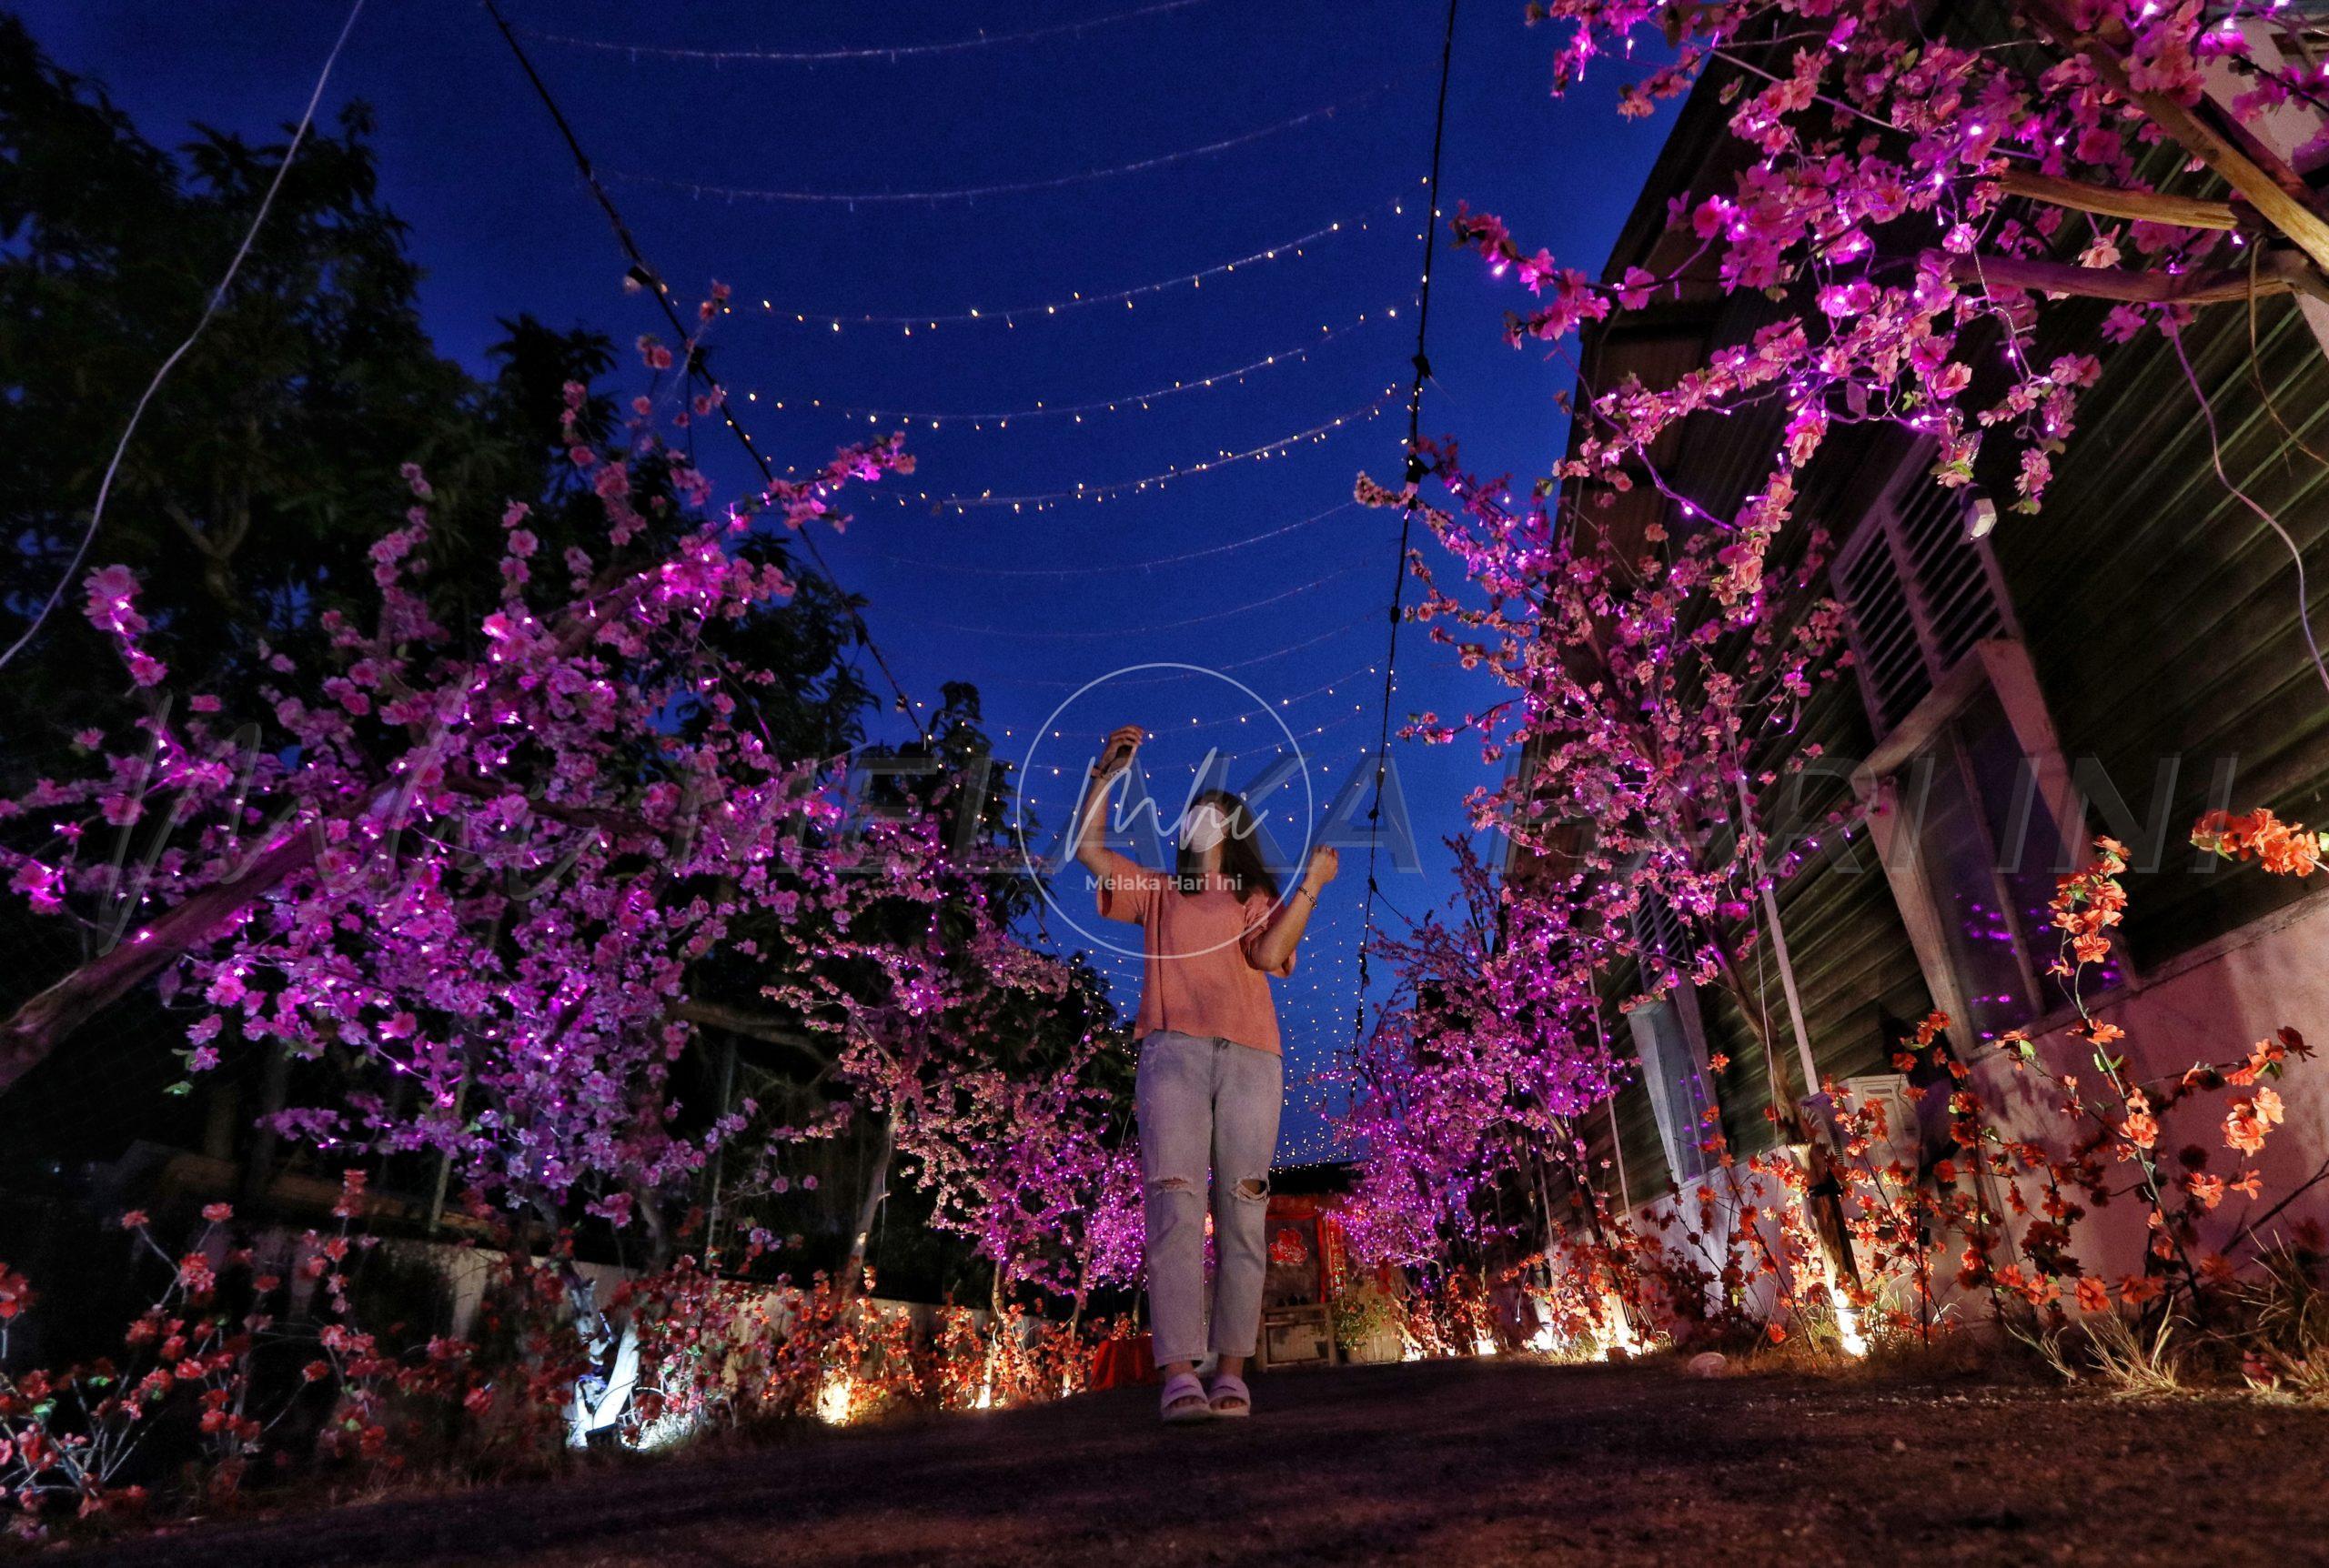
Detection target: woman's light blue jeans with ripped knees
<box><xmin>1134</xmin><ymin>1030</ymin><xmax>1285</xmax><ymax>1365</ymax></box>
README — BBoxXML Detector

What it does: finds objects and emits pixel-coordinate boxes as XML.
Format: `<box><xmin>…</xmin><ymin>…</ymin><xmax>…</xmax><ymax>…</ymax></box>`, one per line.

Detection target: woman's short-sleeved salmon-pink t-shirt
<box><xmin>1094</xmin><ymin>850</ymin><xmax>1295</xmax><ymax>1055</ymax></box>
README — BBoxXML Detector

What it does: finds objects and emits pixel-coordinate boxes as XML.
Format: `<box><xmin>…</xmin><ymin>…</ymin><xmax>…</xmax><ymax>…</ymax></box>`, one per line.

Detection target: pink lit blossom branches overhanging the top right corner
<box><xmin>1453</xmin><ymin>0</ymin><xmax>2329</xmax><ymax>603</ymax></box>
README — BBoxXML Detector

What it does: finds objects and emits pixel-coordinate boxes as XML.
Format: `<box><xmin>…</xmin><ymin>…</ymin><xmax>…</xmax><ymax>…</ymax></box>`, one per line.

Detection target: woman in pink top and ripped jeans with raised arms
<box><xmin>1076</xmin><ymin>725</ymin><xmax>1339</xmax><ymax>1422</ymax></box>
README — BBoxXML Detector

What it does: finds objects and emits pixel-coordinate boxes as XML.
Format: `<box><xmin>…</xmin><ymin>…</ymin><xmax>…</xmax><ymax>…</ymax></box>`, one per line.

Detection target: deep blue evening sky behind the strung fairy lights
<box><xmin>21</xmin><ymin>0</ymin><xmax>1668</xmax><ymax>1162</ymax></box>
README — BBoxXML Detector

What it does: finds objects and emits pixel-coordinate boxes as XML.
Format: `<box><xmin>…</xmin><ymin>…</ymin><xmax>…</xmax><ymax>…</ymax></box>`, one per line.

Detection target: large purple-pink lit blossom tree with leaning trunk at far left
<box><xmin>0</xmin><ymin>305</ymin><xmax>915</xmax><ymax>1228</ymax></box>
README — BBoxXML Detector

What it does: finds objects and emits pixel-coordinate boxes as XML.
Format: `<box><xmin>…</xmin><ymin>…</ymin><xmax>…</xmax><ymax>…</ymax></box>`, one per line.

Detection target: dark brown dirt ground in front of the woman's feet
<box><xmin>46</xmin><ymin>1361</ymin><xmax>2329</xmax><ymax>1568</ymax></box>
